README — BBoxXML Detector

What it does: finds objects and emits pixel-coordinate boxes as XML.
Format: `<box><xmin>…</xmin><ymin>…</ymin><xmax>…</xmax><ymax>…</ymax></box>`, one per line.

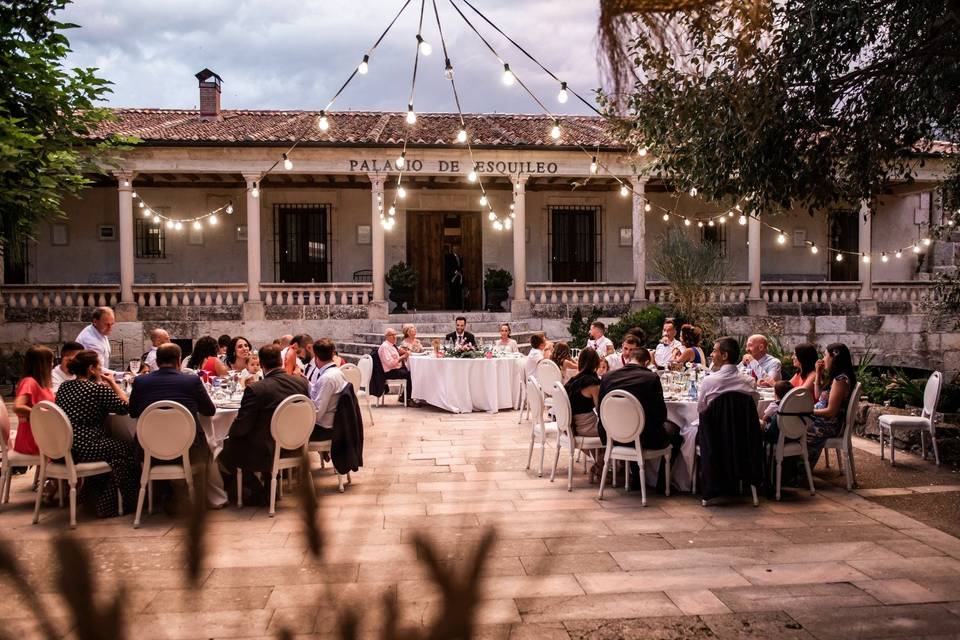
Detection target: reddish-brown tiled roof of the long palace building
<box><xmin>93</xmin><ymin>109</ymin><xmax>623</xmax><ymax>149</ymax></box>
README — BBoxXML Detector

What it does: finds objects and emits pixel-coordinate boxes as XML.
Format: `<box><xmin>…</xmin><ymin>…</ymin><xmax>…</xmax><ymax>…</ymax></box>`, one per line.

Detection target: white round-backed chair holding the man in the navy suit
<box><xmin>133</xmin><ymin>400</ymin><xmax>197</xmax><ymax>529</ymax></box>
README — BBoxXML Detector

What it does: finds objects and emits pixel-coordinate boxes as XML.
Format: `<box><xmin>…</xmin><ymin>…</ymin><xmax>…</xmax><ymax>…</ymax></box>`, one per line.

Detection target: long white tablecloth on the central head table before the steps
<box><xmin>408</xmin><ymin>356</ymin><xmax>523</xmax><ymax>413</ymax></box>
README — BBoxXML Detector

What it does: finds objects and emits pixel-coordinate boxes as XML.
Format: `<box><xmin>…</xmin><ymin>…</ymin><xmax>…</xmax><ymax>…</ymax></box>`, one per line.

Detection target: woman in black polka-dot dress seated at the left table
<box><xmin>57</xmin><ymin>350</ymin><xmax>140</xmax><ymax>518</ymax></box>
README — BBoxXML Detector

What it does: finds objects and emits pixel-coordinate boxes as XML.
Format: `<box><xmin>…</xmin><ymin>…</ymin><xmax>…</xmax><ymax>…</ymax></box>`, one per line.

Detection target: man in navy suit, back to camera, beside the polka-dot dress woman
<box><xmin>130</xmin><ymin>342</ymin><xmax>217</xmax><ymax>447</ymax></box>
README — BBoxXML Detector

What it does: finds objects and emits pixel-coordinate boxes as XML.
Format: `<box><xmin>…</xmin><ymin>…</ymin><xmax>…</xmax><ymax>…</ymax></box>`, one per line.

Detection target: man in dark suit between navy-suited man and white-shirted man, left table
<box><xmin>217</xmin><ymin>344</ymin><xmax>310</xmax><ymax>504</ymax></box>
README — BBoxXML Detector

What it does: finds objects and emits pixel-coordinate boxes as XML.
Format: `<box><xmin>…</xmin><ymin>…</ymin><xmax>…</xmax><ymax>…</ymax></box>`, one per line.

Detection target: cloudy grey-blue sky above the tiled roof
<box><xmin>61</xmin><ymin>0</ymin><xmax>600</xmax><ymax>113</ymax></box>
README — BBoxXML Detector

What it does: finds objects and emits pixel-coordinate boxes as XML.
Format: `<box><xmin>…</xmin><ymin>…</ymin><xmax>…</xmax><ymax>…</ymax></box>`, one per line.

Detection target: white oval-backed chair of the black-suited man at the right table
<box><xmin>597</xmin><ymin>389</ymin><xmax>673</xmax><ymax>507</ymax></box>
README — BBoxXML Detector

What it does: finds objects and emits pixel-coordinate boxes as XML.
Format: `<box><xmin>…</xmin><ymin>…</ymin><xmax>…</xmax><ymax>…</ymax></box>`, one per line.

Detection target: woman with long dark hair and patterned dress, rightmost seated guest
<box><xmin>807</xmin><ymin>342</ymin><xmax>857</xmax><ymax>469</ymax></box>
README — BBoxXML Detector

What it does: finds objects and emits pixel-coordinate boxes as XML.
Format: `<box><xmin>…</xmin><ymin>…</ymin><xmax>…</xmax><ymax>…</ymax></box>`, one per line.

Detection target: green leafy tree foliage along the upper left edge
<box><xmin>0</xmin><ymin>0</ymin><xmax>132</xmax><ymax>257</ymax></box>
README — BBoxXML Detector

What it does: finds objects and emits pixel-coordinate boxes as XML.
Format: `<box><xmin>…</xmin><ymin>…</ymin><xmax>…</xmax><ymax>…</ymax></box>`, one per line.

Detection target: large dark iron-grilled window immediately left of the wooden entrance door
<box><xmin>273</xmin><ymin>204</ymin><xmax>333</xmax><ymax>282</ymax></box>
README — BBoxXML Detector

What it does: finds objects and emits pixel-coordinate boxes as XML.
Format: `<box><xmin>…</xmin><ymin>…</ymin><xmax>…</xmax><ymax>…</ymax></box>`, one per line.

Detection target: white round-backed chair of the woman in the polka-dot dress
<box><xmin>30</xmin><ymin>400</ymin><xmax>123</xmax><ymax>529</ymax></box>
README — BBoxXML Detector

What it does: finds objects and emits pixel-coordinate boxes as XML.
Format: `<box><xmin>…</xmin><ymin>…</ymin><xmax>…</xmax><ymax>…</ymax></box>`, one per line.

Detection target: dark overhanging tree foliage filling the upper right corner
<box><xmin>600</xmin><ymin>0</ymin><xmax>960</xmax><ymax>218</ymax></box>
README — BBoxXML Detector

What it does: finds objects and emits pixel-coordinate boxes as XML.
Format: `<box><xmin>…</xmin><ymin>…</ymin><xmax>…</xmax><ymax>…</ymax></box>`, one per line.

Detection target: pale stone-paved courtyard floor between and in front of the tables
<box><xmin>0</xmin><ymin>404</ymin><xmax>960</xmax><ymax>640</ymax></box>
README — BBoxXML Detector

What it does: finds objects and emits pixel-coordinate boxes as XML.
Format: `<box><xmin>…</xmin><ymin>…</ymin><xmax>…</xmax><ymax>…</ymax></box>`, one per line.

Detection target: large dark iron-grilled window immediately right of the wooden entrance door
<box><xmin>547</xmin><ymin>205</ymin><xmax>603</xmax><ymax>282</ymax></box>
